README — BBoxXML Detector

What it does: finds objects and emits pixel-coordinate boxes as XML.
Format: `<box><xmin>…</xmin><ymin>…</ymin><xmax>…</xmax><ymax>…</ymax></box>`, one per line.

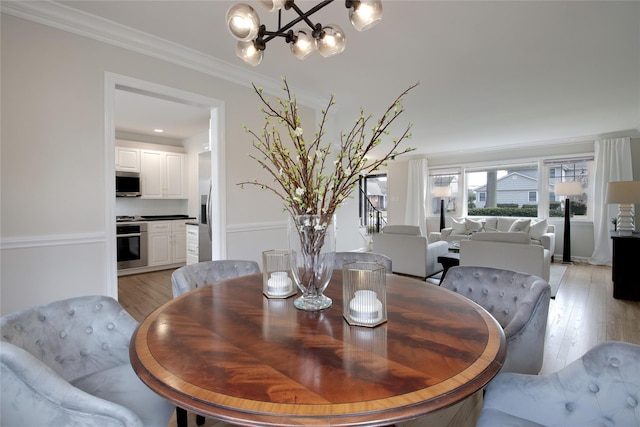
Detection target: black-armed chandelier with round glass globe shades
<box><xmin>226</xmin><ymin>0</ymin><xmax>382</xmax><ymax>67</ymax></box>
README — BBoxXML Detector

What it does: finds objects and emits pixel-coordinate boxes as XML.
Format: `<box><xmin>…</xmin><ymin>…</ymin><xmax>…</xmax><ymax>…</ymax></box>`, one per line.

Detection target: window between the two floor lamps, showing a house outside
<box><xmin>465</xmin><ymin>162</ymin><xmax>539</xmax><ymax>217</ymax></box>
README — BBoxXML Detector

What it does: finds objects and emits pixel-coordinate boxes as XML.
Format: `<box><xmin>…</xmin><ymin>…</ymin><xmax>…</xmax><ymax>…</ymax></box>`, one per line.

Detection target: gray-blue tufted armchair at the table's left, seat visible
<box><xmin>0</xmin><ymin>296</ymin><xmax>175</xmax><ymax>427</ymax></box>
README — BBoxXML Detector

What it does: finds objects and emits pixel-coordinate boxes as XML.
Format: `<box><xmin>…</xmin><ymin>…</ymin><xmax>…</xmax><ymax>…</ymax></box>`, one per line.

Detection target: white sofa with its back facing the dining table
<box><xmin>460</xmin><ymin>231</ymin><xmax>551</xmax><ymax>282</ymax></box>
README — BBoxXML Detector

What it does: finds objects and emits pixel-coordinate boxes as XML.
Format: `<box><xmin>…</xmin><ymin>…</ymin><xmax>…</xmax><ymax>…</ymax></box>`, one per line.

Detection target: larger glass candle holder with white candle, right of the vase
<box><xmin>342</xmin><ymin>262</ymin><xmax>387</xmax><ymax>327</ymax></box>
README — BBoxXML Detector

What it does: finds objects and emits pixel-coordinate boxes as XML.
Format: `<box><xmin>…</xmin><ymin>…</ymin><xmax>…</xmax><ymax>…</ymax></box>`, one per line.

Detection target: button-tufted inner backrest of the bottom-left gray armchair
<box><xmin>0</xmin><ymin>296</ymin><xmax>138</xmax><ymax>382</ymax></box>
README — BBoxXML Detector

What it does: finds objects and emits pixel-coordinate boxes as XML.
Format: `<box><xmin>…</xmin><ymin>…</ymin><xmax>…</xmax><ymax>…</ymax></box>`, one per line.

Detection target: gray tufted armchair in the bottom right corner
<box><xmin>476</xmin><ymin>341</ymin><xmax>640</xmax><ymax>427</ymax></box>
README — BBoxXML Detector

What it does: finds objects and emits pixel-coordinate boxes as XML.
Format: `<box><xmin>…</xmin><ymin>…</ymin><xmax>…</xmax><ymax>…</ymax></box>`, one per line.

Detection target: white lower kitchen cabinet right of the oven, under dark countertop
<box><xmin>147</xmin><ymin>221</ymin><xmax>187</xmax><ymax>267</ymax></box>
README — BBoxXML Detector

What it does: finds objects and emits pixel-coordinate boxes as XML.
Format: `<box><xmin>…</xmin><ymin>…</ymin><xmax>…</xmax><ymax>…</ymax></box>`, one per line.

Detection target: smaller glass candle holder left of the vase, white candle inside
<box><xmin>262</xmin><ymin>249</ymin><xmax>296</xmax><ymax>298</ymax></box>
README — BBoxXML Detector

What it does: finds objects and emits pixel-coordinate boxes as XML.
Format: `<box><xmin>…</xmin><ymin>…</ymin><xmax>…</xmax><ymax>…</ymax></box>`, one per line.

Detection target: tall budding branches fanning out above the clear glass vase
<box><xmin>239</xmin><ymin>78</ymin><xmax>418</xmax><ymax>229</ymax></box>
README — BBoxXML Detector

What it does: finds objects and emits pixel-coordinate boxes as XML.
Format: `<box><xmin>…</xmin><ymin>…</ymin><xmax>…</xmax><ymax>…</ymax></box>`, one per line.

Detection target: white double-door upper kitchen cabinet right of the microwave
<box><xmin>140</xmin><ymin>150</ymin><xmax>187</xmax><ymax>199</ymax></box>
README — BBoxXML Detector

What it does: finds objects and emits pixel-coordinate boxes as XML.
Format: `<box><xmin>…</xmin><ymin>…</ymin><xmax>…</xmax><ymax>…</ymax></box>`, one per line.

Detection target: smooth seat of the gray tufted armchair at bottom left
<box><xmin>71</xmin><ymin>363</ymin><xmax>175</xmax><ymax>426</ymax></box>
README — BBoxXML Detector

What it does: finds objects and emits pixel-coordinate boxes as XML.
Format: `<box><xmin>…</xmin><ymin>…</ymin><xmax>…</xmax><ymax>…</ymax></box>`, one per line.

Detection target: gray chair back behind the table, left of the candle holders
<box><xmin>171</xmin><ymin>260</ymin><xmax>260</xmax><ymax>298</ymax></box>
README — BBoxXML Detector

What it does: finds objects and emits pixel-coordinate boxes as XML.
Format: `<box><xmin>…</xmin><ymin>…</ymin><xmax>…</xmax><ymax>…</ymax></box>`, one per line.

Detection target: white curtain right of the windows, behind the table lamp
<box><xmin>589</xmin><ymin>138</ymin><xmax>633</xmax><ymax>265</ymax></box>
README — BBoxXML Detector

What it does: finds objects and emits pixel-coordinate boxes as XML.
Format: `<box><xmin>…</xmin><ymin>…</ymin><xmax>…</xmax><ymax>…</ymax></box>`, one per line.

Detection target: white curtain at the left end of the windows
<box><xmin>404</xmin><ymin>159</ymin><xmax>429</xmax><ymax>236</ymax></box>
